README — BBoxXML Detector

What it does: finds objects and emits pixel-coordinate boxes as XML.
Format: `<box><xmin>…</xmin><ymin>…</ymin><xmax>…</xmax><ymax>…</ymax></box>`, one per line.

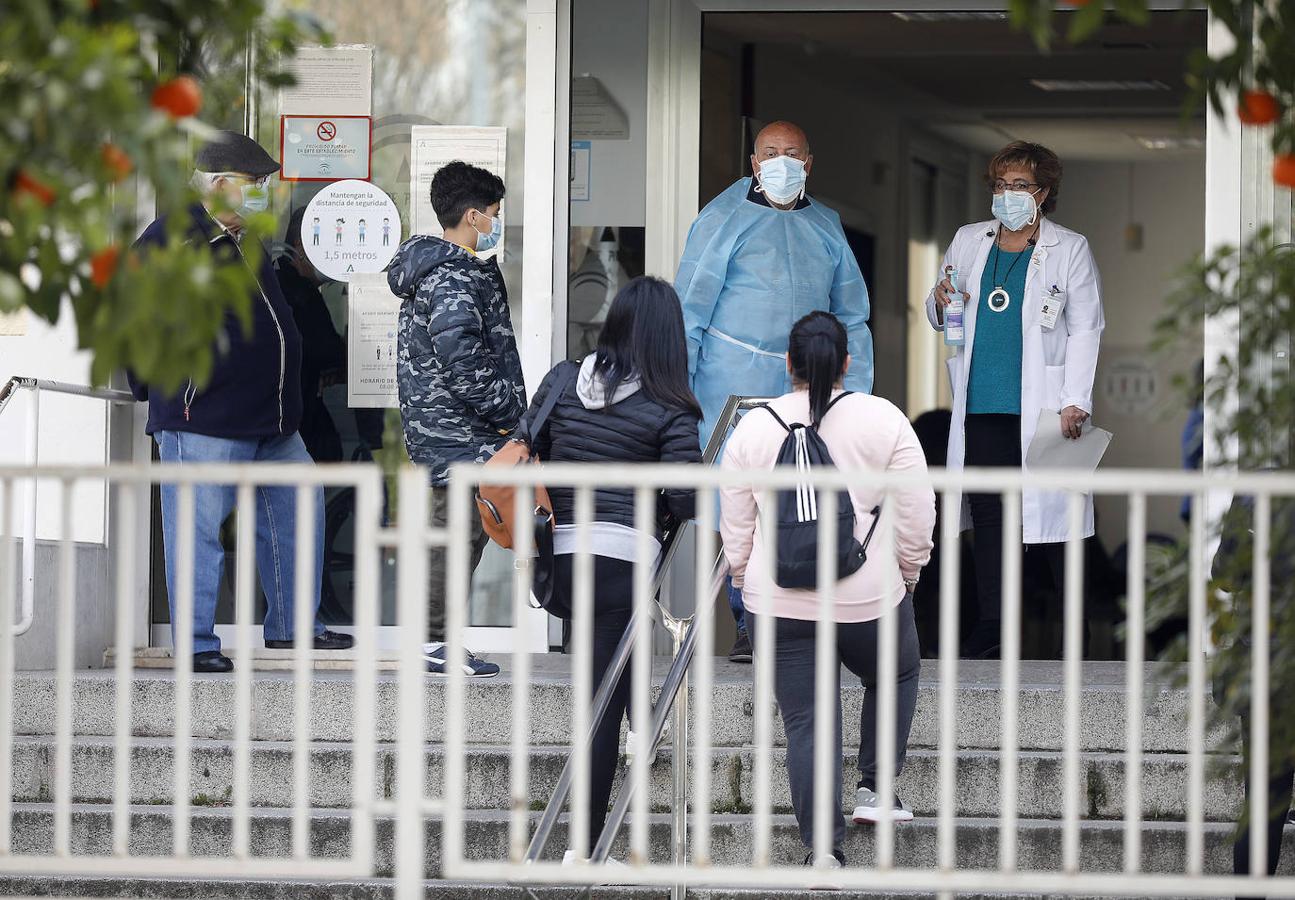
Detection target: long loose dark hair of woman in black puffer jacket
<box><xmin>593</xmin><ymin>276</ymin><xmax>702</xmax><ymax>418</ymax></box>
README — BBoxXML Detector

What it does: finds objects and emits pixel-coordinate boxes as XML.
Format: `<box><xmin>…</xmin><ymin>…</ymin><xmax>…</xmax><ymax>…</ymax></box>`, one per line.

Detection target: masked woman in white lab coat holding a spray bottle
<box><xmin>926</xmin><ymin>141</ymin><xmax>1106</xmax><ymax>658</ymax></box>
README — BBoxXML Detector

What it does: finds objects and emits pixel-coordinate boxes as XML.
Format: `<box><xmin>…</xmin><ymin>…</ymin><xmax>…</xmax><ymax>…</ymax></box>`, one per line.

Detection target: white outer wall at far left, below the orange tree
<box><xmin>0</xmin><ymin>304</ymin><xmax>109</xmax><ymax>544</ymax></box>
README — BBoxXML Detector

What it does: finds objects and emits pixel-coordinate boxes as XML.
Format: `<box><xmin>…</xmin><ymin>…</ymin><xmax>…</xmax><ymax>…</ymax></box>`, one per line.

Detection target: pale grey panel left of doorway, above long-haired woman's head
<box><xmin>571</xmin><ymin>0</ymin><xmax>648</xmax><ymax>228</ymax></box>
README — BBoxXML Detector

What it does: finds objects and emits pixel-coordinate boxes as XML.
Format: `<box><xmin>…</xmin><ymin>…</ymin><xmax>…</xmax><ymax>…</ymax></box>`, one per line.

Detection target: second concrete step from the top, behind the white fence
<box><xmin>13</xmin><ymin>737</ymin><xmax>1241</xmax><ymax>821</ymax></box>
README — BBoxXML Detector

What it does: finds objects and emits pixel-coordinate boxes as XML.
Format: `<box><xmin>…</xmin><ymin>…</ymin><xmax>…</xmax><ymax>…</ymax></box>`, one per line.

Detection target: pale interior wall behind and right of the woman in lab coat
<box><xmin>1053</xmin><ymin>155</ymin><xmax>1206</xmax><ymax>550</ymax></box>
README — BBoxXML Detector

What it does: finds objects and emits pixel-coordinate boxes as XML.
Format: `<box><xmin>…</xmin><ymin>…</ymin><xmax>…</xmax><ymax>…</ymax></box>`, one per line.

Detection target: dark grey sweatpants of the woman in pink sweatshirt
<box><xmin>746</xmin><ymin>594</ymin><xmax>922</xmax><ymax>848</ymax></box>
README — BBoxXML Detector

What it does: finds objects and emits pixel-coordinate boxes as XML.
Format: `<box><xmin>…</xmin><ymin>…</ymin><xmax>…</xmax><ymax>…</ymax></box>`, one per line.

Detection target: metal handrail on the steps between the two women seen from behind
<box><xmin>526</xmin><ymin>395</ymin><xmax>767</xmax><ymax>897</ymax></box>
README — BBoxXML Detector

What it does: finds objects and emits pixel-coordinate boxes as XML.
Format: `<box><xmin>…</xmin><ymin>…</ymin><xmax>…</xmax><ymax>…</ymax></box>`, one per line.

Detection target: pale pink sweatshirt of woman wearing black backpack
<box><xmin>720</xmin><ymin>390</ymin><xmax>935</xmax><ymax>622</ymax></box>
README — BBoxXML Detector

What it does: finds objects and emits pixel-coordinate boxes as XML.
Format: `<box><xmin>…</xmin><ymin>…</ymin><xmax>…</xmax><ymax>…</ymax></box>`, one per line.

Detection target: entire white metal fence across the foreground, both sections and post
<box><xmin>0</xmin><ymin>465</ymin><xmax>1295</xmax><ymax>899</ymax></box>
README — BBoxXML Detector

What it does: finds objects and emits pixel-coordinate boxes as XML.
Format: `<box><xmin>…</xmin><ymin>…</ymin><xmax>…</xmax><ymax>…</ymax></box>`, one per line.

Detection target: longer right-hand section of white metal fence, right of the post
<box><xmin>437</xmin><ymin>465</ymin><xmax>1295</xmax><ymax>897</ymax></box>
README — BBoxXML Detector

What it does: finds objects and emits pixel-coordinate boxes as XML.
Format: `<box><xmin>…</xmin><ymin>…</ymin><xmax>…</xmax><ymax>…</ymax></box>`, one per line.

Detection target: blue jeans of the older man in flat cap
<box><xmin>154</xmin><ymin>431</ymin><xmax>324</xmax><ymax>653</ymax></box>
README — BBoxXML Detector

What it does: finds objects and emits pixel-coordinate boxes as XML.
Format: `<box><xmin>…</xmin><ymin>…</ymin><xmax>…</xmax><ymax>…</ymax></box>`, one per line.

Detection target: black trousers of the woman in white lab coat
<box><xmin>963</xmin><ymin>413</ymin><xmax>1088</xmax><ymax>631</ymax></box>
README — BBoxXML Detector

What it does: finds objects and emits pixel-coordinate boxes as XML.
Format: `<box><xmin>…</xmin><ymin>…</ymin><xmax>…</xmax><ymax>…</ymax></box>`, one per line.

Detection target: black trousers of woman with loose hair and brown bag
<box><xmin>553</xmin><ymin>554</ymin><xmax>635</xmax><ymax>855</ymax></box>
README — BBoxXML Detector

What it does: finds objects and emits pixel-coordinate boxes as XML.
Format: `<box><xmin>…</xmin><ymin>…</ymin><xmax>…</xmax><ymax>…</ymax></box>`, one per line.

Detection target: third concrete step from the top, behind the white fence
<box><xmin>5</xmin><ymin>804</ymin><xmax>1295</xmax><ymax>878</ymax></box>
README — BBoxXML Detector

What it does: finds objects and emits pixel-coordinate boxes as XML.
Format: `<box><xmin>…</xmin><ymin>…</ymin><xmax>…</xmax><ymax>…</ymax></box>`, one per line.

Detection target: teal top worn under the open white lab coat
<box><xmin>967</xmin><ymin>246</ymin><xmax>1033</xmax><ymax>416</ymax></box>
